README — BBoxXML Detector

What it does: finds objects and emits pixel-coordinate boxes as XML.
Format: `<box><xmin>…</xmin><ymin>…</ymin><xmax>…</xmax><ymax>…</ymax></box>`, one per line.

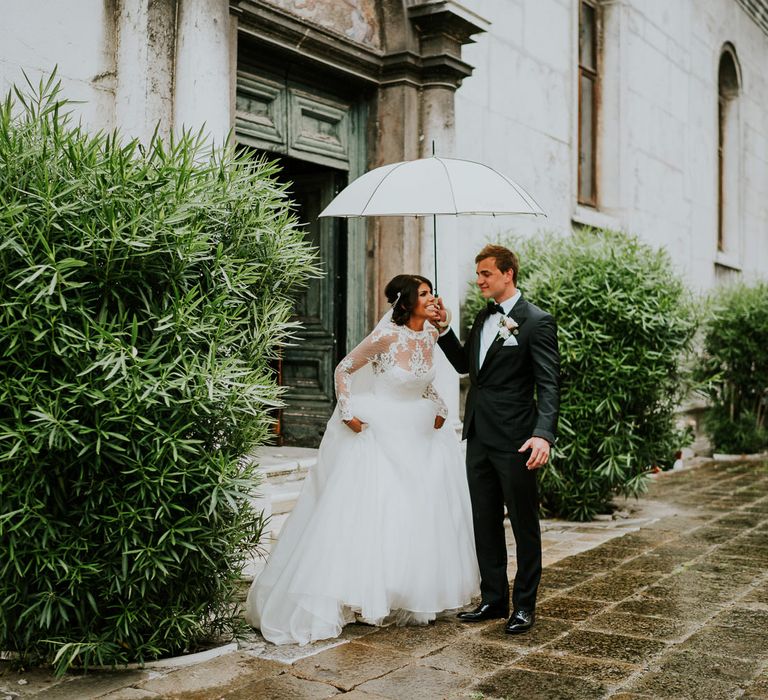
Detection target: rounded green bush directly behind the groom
<box><xmin>465</xmin><ymin>230</ymin><xmax>695</xmax><ymax>520</ymax></box>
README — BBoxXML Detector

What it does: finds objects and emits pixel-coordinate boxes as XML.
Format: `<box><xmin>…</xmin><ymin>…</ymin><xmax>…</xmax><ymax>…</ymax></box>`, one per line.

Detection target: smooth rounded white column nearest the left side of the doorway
<box><xmin>173</xmin><ymin>0</ymin><xmax>231</xmax><ymax>144</ymax></box>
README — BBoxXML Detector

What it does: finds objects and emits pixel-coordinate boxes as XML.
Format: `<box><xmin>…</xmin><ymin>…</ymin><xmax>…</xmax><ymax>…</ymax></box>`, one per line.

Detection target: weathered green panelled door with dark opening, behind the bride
<box><xmin>235</xmin><ymin>58</ymin><xmax>366</xmax><ymax>447</ymax></box>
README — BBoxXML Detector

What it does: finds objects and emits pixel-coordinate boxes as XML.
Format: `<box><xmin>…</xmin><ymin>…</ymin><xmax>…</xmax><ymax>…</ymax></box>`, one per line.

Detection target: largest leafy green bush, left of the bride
<box><xmin>0</xmin><ymin>74</ymin><xmax>316</xmax><ymax>671</ymax></box>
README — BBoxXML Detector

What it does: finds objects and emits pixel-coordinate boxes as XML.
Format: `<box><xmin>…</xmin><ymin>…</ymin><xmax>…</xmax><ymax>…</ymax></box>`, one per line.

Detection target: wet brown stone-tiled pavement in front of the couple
<box><xmin>6</xmin><ymin>462</ymin><xmax>768</xmax><ymax>700</ymax></box>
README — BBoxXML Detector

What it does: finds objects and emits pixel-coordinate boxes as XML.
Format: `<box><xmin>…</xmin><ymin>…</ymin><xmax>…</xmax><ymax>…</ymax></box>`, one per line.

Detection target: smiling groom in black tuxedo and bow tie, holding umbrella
<box><xmin>436</xmin><ymin>245</ymin><xmax>560</xmax><ymax>634</ymax></box>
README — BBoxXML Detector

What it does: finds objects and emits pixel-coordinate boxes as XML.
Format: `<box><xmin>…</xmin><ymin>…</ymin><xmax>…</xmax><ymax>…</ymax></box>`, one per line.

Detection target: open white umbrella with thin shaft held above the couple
<box><xmin>320</xmin><ymin>156</ymin><xmax>546</xmax><ymax>288</ymax></box>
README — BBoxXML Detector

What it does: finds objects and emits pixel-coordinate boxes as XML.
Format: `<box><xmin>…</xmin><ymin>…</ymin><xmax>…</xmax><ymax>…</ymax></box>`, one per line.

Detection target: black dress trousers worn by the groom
<box><xmin>467</xmin><ymin>436</ymin><xmax>541</xmax><ymax>611</ymax></box>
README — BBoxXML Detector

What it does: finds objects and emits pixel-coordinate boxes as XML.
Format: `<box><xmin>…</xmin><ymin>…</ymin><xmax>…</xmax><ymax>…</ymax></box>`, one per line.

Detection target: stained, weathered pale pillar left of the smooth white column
<box><xmin>115</xmin><ymin>0</ymin><xmax>176</xmax><ymax>143</ymax></box>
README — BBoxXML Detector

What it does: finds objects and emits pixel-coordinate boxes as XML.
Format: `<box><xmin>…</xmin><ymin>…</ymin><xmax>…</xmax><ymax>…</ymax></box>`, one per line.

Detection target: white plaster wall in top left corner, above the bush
<box><xmin>0</xmin><ymin>0</ymin><xmax>115</xmax><ymax>129</ymax></box>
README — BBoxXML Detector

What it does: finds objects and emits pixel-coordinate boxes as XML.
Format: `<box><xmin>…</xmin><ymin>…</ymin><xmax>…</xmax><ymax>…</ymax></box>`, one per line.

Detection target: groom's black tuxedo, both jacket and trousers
<box><xmin>438</xmin><ymin>297</ymin><xmax>560</xmax><ymax>610</ymax></box>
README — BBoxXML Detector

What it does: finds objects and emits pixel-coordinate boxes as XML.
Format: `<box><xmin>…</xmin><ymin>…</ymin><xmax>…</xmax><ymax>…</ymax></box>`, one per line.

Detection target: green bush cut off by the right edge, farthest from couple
<box><xmin>696</xmin><ymin>282</ymin><xmax>768</xmax><ymax>454</ymax></box>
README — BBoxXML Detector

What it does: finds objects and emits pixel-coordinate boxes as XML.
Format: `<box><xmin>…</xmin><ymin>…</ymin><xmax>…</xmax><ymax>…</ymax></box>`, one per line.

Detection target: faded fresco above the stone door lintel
<box><xmin>269</xmin><ymin>0</ymin><xmax>381</xmax><ymax>48</ymax></box>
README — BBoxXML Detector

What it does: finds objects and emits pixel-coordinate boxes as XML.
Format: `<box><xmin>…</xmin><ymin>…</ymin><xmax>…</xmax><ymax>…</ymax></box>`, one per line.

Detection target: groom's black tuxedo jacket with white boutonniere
<box><xmin>438</xmin><ymin>297</ymin><xmax>560</xmax><ymax>452</ymax></box>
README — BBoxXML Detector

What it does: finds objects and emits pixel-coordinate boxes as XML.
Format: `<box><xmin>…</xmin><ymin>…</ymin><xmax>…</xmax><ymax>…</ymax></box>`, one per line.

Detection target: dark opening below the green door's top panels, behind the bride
<box><xmin>267</xmin><ymin>154</ymin><xmax>347</xmax><ymax>447</ymax></box>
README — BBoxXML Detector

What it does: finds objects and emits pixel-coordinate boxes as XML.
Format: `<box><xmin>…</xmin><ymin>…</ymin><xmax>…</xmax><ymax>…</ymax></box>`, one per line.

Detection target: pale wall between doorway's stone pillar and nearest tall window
<box><xmin>455</xmin><ymin>0</ymin><xmax>575</xmax><ymax>288</ymax></box>
